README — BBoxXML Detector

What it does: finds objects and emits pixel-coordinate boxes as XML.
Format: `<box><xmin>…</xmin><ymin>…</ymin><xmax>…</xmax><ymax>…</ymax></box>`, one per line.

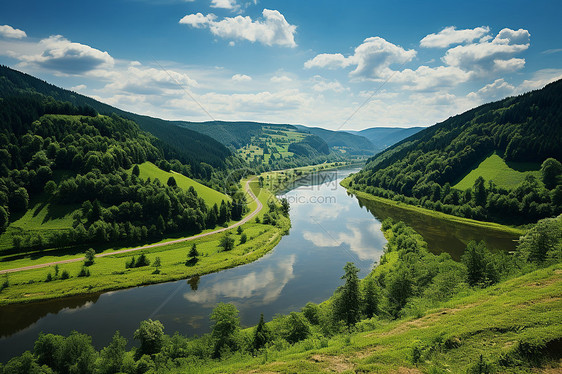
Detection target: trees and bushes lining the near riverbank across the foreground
<box><xmin>0</xmin><ymin>216</ymin><xmax>562</xmax><ymax>374</ymax></box>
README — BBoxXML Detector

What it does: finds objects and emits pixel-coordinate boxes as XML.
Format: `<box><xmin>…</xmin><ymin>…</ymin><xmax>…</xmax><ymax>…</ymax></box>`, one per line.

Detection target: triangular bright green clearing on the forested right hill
<box><xmin>453</xmin><ymin>153</ymin><xmax>541</xmax><ymax>190</ymax></box>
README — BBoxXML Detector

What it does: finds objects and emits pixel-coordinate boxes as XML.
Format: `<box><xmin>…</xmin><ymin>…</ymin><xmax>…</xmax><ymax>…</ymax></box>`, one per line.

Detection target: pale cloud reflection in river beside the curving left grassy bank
<box><xmin>183</xmin><ymin>255</ymin><xmax>296</xmax><ymax>308</ymax></box>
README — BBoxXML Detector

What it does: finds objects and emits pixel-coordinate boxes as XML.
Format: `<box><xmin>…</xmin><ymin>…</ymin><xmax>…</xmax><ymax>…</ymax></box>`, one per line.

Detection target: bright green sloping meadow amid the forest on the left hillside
<box><xmin>128</xmin><ymin>161</ymin><xmax>230</xmax><ymax>206</ymax></box>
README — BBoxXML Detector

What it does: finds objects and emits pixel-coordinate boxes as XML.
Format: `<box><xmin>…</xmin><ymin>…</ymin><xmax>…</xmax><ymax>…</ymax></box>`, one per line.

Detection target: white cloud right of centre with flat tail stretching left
<box><xmin>304</xmin><ymin>36</ymin><xmax>416</xmax><ymax>79</ymax></box>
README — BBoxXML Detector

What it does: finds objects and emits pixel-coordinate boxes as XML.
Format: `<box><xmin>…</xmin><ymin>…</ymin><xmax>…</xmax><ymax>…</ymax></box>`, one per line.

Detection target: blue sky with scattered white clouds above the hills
<box><xmin>0</xmin><ymin>0</ymin><xmax>562</xmax><ymax>130</ymax></box>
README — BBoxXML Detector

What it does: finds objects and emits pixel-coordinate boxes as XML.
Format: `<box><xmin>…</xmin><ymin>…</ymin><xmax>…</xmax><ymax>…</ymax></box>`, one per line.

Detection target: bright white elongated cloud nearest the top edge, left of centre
<box><xmin>180</xmin><ymin>9</ymin><xmax>297</xmax><ymax>47</ymax></box>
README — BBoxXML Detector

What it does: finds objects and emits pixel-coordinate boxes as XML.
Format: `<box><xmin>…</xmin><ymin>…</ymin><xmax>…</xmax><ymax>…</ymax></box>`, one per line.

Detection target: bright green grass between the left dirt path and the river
<box><xmin>0</xmin><ymin>181</ymin><xmax>290</xmax><ymax>305</ymax></box>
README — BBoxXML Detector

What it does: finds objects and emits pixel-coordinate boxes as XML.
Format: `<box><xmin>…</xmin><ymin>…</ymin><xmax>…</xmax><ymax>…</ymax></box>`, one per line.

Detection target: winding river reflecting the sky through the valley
<box><xmin>0</xmin><ymin>170</ymin><xmax>516</xmax><ymax>362</ymax></box>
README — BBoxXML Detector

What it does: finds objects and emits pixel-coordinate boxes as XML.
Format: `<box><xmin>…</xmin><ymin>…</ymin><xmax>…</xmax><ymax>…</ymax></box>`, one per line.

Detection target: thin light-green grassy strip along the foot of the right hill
<box><xmin>340</xmin><ymin>177</ymin><xmax>525</xmax><ymax>236</ymax></box>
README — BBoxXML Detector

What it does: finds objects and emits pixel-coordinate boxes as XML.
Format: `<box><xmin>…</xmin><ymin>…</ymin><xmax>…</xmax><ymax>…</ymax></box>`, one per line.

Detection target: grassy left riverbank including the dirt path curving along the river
<box><xmin>0</xmin><ymin>180</ymin><xmax>284</xmax><ymax>305</ymax></box>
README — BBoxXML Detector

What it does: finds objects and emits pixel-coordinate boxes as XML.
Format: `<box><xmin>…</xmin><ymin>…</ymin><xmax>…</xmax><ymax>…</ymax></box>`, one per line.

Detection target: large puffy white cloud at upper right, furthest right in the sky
<box><xmin>443</xmin><ymin>29</ymin><xmax>530</xmax><ymax>75</ymax></box>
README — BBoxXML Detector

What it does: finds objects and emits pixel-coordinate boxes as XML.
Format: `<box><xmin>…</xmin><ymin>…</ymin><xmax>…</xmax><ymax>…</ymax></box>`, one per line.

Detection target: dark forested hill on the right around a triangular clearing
<box><xmin>351</xmin><ymin>81</ymin><xmax>562</xmax><ymax>223</ymax></box>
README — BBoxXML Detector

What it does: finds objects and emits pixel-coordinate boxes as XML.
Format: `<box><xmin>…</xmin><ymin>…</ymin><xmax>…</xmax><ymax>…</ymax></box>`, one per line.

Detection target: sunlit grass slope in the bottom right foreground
<box><xmin>189</xmin><ymin>264</ymin><xmax>562</xmax><ymax>373</ymax></box>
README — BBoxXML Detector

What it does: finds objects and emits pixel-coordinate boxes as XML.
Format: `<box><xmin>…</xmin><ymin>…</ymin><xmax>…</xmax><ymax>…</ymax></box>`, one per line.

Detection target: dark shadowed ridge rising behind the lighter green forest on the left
<box><xmin>0</xmin><ymin>66</ymin><xmax>232</xmax><ymax>174</ymax></box>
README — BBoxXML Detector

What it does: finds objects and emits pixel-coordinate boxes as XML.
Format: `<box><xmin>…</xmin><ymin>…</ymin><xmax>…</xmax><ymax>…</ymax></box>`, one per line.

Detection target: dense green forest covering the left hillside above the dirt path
<box><xmin>0</xmin><ymin>96</ymin><xmax>246</xmax><ymax>250</ymax></box>
